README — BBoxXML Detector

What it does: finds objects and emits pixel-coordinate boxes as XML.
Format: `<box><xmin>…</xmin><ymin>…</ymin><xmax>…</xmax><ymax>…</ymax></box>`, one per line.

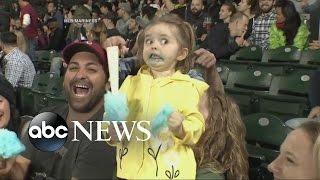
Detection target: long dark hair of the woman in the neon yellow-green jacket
<box><xmin>275</xmin><ymin>0</ymin><xmax>301</xmax><ymax>45</ymax></box>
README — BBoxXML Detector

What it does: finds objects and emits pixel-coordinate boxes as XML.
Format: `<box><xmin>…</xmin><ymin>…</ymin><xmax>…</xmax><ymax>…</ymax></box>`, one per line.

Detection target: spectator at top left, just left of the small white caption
<box><xmin>43</xmin><ymin>1</ymin><xmax>64</xmax><ymax>29</ymax></box>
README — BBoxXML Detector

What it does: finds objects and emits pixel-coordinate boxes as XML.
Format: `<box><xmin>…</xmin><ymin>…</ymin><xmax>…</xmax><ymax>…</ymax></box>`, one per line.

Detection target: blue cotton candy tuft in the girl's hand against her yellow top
<box><xmin>151</xmin><ymin>105</ymin><xmax>174</xmax><ymax>136</ymax></box>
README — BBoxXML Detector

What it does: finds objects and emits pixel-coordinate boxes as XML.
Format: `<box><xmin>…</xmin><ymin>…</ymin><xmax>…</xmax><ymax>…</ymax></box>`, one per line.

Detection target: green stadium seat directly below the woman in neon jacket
<box><xmin>266</xmin><ymin>46</ymin><xmax>301</xmax><ymax>63</ymax></box>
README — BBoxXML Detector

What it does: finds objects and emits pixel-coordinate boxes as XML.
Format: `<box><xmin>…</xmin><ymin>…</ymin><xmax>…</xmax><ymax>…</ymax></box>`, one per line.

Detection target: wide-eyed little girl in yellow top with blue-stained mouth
<box><xmin>107</xmin><ymin>15</ymin><xmax>208</xmax><ymax>179</ymax></box>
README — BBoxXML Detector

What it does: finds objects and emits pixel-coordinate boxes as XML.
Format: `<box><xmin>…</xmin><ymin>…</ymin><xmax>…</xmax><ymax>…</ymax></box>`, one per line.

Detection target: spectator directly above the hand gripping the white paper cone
<box><xmin>116</xmin><ymin>2</ymin><xmax>131</xmax><ymax>37</ymax></box>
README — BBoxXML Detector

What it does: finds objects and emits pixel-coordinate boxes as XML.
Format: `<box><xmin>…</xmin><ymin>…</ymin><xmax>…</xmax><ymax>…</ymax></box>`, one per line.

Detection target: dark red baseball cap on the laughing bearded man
<box><xmin>62</xmin><ymin>41</ymin><xmax>108</xmax><ymax>70</ymax></box>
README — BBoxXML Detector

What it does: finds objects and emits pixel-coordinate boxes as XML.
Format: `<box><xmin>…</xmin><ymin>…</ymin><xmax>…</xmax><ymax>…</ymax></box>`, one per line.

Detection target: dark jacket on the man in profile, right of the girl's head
<box><xmin>202</xmin><ymin>23</ymin><xmax>240</xmax><ymax>59</ymax></box>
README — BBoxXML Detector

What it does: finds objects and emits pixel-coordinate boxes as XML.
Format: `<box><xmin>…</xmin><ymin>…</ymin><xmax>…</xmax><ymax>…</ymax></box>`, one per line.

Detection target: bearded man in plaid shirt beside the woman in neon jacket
<box><xmin>249</xmin><ymin>0</ymin><xmax>276</xmax><ymax>49</ymax></box>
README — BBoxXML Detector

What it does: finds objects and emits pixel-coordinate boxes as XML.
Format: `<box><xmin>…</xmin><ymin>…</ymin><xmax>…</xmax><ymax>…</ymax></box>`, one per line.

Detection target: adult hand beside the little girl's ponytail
<box><xmin>193</xmin><ymin>48</ymin><xmax>217</xmax><ymax>68</ymax></box>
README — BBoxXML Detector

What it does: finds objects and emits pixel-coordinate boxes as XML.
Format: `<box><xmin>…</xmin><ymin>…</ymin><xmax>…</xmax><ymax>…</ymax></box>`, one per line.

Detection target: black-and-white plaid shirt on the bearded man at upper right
<box><xmin>249</xmin><ymin>10</ymin><xmax>276</xmax><ymax>49</ymax></box>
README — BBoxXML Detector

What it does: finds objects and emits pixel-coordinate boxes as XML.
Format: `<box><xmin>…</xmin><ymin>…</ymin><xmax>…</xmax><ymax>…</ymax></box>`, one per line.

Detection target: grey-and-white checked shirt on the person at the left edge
<box><xmin>4</xmin><ymin>48</ymin><xmax>36</xmax><ymax>88</ymax></box>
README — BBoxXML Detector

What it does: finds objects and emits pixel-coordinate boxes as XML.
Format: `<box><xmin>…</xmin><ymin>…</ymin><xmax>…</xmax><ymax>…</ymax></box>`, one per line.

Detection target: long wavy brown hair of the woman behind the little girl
<box><xmin>194</xmin><ymin>67</ymin><xmax>249</xmax><ymax>179</ymax></box>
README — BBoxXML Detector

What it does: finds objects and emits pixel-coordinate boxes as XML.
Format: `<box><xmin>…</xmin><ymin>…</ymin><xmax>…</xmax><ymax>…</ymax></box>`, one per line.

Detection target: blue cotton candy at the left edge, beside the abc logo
<box><xmin>0</xmin><ymin>129</ymin><xmax>26</xmax><ymax>159</ymax></box>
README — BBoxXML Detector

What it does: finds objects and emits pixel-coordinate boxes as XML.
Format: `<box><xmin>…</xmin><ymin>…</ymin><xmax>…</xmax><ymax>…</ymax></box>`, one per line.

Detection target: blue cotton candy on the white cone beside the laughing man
<box><xmin>104</xmin><ymin>91</ymin><xmax>129</xmax><ymax>121</ymax></box>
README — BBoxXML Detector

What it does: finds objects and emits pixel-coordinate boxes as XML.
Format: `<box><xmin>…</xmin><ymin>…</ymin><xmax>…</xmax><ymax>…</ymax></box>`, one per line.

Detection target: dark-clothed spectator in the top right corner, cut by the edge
<box><xmin>300</xmin><ymin>0</ymin><xmax>320</xmax><ymax>40</ymax></box>
